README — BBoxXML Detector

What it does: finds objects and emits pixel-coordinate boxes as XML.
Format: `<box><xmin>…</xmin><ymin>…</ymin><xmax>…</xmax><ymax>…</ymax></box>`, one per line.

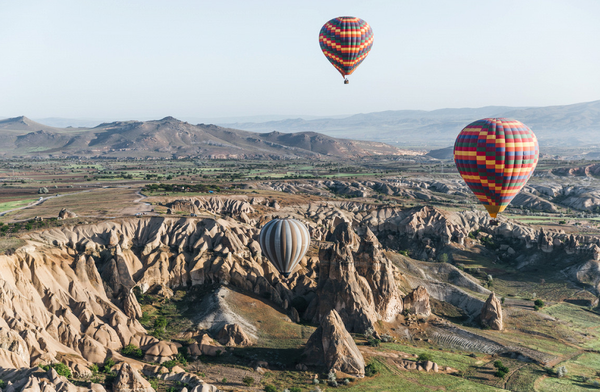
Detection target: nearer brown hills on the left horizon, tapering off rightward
<box><xmin>0</xmin><ymin>117</ymin><xmax>411</xmax><ymax>159</ymax></box>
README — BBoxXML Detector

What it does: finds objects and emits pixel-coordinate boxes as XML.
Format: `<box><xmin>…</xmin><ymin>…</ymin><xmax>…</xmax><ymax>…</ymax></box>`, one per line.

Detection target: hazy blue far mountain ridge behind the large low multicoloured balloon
<box><xmin>220</xmin><ymin>101</ymin><xmax>600</xmax><ymax>148</ymax></box>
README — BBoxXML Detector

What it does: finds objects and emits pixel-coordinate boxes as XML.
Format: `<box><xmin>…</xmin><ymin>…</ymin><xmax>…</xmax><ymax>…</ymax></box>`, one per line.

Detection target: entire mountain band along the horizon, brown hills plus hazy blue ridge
<box><xmin>0</xmin><ymin>101</ymin><xmax>600</xmax><ymax>159</ymax></box>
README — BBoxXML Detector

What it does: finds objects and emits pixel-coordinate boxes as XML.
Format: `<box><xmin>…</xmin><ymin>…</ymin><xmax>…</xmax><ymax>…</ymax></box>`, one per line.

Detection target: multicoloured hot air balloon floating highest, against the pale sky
<box><xmin>319</xmin><ymin>16</ymin><xmax>373</xmax><ymax>84</ymax></box>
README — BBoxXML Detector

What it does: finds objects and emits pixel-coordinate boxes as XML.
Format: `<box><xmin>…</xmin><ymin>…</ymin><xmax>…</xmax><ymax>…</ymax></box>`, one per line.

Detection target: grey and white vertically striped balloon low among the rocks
<box><xmin>260</xmin><ymin>218</ymin><xmax>310</xmax><ymax>278</ymax></box>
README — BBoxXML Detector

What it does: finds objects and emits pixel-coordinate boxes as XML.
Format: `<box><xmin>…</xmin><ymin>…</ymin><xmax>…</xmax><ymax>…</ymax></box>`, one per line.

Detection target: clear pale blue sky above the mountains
<box><xmin>0</xmin><ymin>0</ymin><xmax>600</xmax><ymax>119</ymax></box>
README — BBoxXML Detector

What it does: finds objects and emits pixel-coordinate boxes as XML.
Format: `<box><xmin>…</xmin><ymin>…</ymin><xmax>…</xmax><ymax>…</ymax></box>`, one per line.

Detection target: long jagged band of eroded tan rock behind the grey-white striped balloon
<box><xmin>0</xmin><ymin>199</ymin><xmax>600</xmax><ymax>382</ymax></box>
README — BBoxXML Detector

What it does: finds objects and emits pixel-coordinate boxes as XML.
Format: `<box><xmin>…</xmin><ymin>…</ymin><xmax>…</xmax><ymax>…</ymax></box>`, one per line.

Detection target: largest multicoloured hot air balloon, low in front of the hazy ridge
<box><xmin>454</xmin><ymin>118</ymin><xmax>539</xmax><ymax>218</ymax></box>
